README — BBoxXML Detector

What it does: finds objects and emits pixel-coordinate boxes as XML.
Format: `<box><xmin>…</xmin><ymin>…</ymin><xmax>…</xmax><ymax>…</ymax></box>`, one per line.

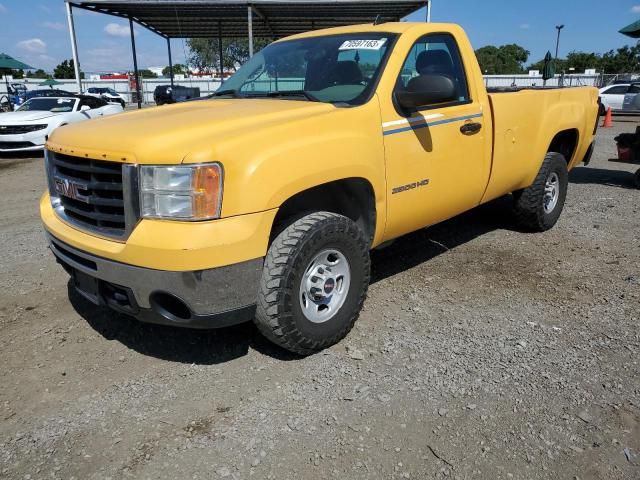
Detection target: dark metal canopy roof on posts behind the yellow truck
<box><xmin>66</xmin><ymin>0</ymin><xmax>429</xmax><ymax>39</ymax></box>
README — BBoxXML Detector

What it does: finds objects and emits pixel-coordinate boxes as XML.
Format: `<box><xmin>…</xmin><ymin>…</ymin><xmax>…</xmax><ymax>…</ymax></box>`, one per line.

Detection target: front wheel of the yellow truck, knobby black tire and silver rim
<box><xmin>255</xmin><ymin>212</ymin><xmax>370</xmax><ymax>355</ymax></box>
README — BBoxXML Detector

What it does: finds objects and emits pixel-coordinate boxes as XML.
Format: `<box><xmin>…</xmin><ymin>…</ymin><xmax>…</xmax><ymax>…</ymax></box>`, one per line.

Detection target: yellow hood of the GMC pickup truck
<box><xmin>47</xmin><ymin>98</ymin><xmax>336</xmax><ymax>164</ymax></box>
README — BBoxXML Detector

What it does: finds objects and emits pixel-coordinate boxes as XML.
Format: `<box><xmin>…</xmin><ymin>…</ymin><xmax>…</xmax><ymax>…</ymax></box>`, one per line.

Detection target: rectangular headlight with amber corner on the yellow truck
<box><xmin>140</xmin><ymin>163</ymin><xmax>222</xmax><ymax>220</ymax></box>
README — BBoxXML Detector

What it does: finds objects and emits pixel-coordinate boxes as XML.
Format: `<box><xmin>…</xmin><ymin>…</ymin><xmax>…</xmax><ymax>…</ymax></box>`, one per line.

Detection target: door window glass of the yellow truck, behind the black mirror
<box><xmin>396</xmin><ymin>33</ymin><xmax>470</xmax><ymax>107</ymax></box>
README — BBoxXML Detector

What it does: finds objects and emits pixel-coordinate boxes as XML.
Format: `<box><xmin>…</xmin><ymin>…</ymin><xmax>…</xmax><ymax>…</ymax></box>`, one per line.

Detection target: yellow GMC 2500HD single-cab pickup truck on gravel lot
<box><xmin>40</xmin><ymin>23</ymin><xmax>598</xmax><ymax>354</ymax></box>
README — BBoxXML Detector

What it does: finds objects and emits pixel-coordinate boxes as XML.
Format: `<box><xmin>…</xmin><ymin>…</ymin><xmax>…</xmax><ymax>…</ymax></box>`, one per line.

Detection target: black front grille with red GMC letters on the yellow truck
<box><xmin>49</xmin><ymin>152</ymin><xmax>126</xmax><ymax>237</ymax></box>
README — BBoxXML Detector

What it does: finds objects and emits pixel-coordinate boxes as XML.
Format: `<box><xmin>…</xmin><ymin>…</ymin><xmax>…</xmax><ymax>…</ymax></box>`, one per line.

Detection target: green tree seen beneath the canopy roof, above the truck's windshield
<box><xmin>187</xmin><ymin>38</ymin><xmax>271</xmax><ymax>72</ymax></box>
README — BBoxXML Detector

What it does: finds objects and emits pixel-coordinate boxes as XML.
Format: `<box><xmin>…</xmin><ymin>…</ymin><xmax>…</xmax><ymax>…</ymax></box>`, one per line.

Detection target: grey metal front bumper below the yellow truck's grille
<box><xmin>47</xmin><ymin>233</ymin><xmax>263</xmax><ymax>328</ymax></box>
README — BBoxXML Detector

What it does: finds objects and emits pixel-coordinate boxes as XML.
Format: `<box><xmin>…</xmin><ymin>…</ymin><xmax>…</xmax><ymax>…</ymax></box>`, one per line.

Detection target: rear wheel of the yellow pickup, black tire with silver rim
<box><xmin>514</xmin><ymin>152</ymin><xmax>569</xmax><ymax>232</ymax></box>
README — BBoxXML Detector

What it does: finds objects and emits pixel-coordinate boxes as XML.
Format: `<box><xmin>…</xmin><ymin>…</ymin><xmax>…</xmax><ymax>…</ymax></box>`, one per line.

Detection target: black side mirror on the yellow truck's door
<box><xmin>395</xmin><ymin>75</ymin><xmax>456</xmax><ymax>109</ymax></box>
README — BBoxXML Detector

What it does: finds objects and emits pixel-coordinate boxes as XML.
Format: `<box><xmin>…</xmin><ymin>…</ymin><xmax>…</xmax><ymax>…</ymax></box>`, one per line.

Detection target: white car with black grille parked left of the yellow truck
<box><xmin>0</xmin><ymin>95</ymin><xmax>122</xmax><ymax>152</ymax></box>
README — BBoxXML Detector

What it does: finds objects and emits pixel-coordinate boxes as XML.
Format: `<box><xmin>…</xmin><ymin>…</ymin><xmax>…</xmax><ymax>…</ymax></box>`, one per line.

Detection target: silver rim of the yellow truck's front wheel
<box><xmin>299</xmin><ymin>249</ymin><xmax>351</xmax><ymax>323</ymax></box>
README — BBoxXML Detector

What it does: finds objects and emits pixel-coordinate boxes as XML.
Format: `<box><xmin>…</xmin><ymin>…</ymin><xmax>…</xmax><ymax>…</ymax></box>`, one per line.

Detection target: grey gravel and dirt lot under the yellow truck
<box><xmin>0</xmin><ymin>119</ymin><xmax>640</xmax><ymax>480</ymax></box>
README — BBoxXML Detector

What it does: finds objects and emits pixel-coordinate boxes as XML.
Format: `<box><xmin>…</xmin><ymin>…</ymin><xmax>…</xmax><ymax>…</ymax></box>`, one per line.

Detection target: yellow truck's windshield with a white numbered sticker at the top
<box><xmin>217</xmin><ymin>33</ymin><xmax>395</xmax><ymax>105</ymax></box>
